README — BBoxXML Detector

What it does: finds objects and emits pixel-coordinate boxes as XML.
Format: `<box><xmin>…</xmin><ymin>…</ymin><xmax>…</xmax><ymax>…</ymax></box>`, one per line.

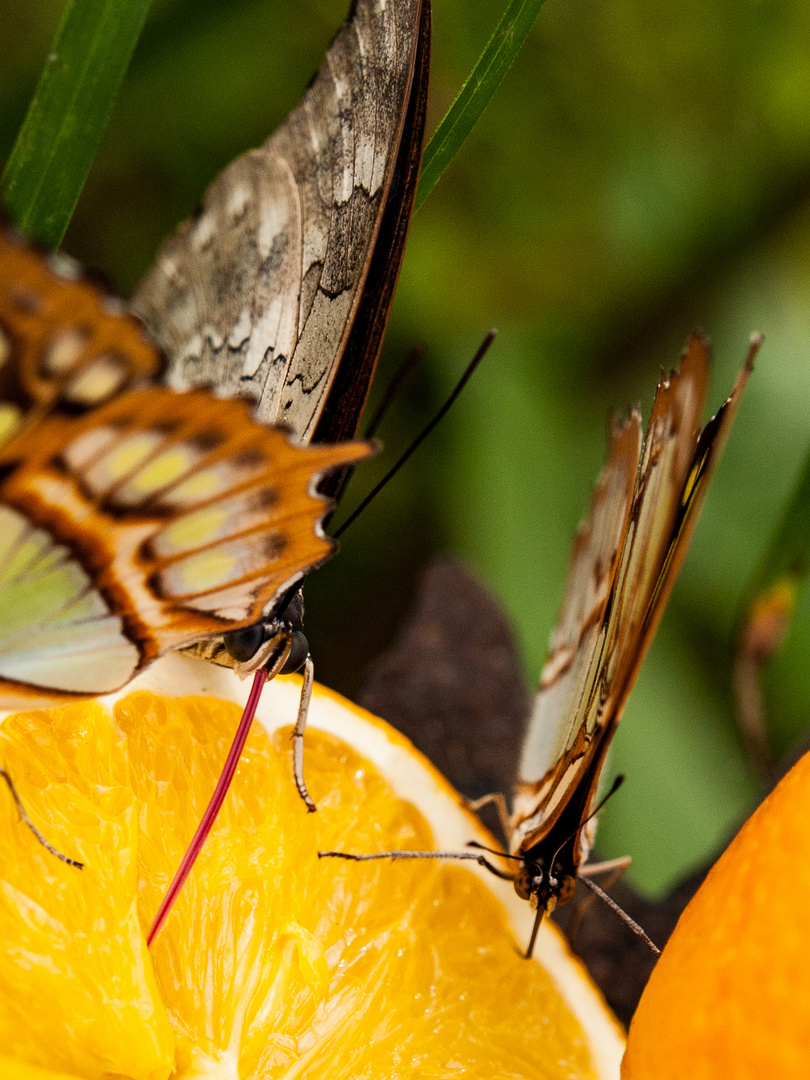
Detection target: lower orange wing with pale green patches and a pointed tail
<box><xmin>0</xmin><ymin>388</ymin><xmax>369</xmax><ymax>707</ymax></box>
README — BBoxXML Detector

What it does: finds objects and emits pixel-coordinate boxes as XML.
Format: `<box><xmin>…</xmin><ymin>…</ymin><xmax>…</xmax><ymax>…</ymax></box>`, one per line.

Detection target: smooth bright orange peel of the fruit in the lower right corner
<box><xmin>622</xmin><ymin>755</ymin><xmax>810</xmax><ymax>1080</ymax></box>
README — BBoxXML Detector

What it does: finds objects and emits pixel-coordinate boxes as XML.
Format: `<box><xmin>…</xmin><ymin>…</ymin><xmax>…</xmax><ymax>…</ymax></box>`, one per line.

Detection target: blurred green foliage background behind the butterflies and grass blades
<box><xmin>0</xmin><ymin>0</ymin><xmax>810</xmax><ymax>895</ymax></box>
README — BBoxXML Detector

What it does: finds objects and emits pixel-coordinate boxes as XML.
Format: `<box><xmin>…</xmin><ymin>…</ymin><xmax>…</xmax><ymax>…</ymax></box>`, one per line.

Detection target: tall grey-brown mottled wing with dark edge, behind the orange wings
<box><xmin>133</xmin><ymin>0</ymin><xmax>430</xmax><ymax>442</ymax></box>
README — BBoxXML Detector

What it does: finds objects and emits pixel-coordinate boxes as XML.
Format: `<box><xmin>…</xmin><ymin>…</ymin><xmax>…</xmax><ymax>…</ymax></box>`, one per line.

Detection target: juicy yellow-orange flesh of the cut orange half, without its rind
<box><xmin>0</xmin><ymin>692</ymin><xmax>596</xmax><ymax>1080</ymax></box>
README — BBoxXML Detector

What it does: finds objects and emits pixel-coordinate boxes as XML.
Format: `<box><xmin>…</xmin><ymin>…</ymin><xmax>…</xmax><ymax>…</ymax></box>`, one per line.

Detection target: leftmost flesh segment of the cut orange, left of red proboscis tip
<box><xmin>0</xmin><ymin>703</ymin><xmax>173</xmax><ymax>1080</ymax></box>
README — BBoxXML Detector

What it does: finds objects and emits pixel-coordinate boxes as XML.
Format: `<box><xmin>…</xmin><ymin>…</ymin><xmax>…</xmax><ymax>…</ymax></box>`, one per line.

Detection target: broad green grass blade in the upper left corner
<box><xmin>0</xmin><ymin>0</ymin><xmax>149</xmax><ymax>247</ymax></box>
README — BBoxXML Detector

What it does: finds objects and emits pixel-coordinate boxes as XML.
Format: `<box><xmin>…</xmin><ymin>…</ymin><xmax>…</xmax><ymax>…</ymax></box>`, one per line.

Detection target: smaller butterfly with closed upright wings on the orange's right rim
<box><xmin>324</xmin><ymin>334</ymin><xmax>760</xmax><ymax>955</ymax></box>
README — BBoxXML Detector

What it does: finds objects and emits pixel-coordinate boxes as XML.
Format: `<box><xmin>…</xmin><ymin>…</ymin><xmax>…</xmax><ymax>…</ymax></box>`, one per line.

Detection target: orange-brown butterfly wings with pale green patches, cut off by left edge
<box><xmin>0</xmin><ymin>220</ymin><xmax>370</xmax><ymax>708</ymax></box>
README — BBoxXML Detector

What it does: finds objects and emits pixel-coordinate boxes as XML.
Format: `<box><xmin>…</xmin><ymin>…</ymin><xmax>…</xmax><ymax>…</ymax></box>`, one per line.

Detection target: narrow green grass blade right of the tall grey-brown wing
<box><xmin>416</xmin><ymin>0</ymin><xmax>543</xmax><ymax>210</ymax></box>
